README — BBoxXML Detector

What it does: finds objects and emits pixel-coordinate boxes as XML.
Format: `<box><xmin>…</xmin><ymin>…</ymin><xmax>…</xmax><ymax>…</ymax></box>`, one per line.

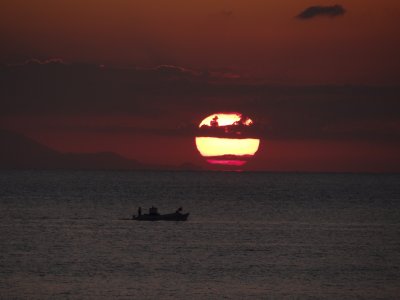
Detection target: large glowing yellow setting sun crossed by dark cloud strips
<box><xmin>195</xmin><ymin>112</ymin><xmax>260</xmax><ymax>166</ymax></box>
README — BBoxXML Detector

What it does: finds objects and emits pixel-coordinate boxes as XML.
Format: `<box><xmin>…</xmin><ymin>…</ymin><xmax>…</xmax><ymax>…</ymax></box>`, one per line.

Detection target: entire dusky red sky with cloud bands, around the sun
<box><xmin>0</xmin><ymin>0</ymin><xmax>400</xmax><ymax>171</ymax></box>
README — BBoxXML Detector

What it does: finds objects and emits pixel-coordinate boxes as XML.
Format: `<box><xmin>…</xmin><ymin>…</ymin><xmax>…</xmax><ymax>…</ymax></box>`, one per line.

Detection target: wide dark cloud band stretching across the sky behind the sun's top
<box><xmin>0</xmin><ymin>61</ymin><xmax>400</xmax><ymax>142</ymax></box>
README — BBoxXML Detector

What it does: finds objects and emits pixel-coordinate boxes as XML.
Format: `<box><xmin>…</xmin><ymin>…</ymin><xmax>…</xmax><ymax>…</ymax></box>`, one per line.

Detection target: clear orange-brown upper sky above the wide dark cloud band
<box><xmin>0</xmin><ymin>0</ymin><xmax>400</xmax><ymax>84</ymax></box>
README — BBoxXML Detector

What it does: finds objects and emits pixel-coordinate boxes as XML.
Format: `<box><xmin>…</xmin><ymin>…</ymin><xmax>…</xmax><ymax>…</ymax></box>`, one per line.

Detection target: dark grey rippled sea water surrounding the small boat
<box><xmin>0</xmin><ymin>171</ymin><xmax>400</xmax><ymax>299</ymax></box>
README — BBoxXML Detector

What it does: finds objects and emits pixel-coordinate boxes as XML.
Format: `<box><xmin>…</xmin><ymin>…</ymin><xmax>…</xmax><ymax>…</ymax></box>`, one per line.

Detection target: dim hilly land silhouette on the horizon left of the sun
<box><xmin>0</xmin><ymin>129</ymin><xmax>201</xmax><ymax>170</ymax></box>
